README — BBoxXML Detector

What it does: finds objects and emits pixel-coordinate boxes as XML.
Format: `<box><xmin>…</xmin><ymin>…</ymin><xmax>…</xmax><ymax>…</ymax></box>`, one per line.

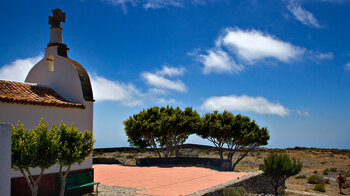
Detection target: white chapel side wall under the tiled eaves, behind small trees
<box><xmin>0</xmin><ymin>101</ymin><xmax>93</xmax><ymax>177</ymax></box>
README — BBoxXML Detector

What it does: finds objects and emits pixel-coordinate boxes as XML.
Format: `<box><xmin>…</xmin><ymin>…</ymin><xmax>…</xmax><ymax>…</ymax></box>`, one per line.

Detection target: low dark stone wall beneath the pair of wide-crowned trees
<box><xmin>136</xmin><ymin>157</ymin><xmax>232</xmax><ymax>171</ymax></box>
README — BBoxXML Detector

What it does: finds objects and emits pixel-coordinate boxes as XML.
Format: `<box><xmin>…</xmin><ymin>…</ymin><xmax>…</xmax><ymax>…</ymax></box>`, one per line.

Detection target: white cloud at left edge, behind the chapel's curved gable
<box><xmin>0</xmin><ymin>54</ymin><xmax>43</xmax><ymax>82</ymax></box>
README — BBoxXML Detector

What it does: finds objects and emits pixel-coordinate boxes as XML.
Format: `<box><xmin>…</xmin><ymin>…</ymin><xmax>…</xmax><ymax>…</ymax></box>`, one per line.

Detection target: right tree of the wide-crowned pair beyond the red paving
<box><xmin>197</xmin><ymin>111</ymin><xmax>270</xmax><ymax>169</ymax></box>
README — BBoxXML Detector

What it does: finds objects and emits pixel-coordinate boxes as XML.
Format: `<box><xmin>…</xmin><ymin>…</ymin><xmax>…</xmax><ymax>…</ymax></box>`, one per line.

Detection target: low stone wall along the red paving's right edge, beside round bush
<box><xmin>189</xmin><ymin>171</ymin><xmax>274</xmax><ymax>196</ymax></box>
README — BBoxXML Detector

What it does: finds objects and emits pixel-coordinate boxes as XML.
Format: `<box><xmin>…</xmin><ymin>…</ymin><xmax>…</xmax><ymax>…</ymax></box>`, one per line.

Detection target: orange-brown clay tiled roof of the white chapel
<box><xmin>0</xmin><ymin>80</ymin><xmax>85</xmax><ymax>109</ymax></box>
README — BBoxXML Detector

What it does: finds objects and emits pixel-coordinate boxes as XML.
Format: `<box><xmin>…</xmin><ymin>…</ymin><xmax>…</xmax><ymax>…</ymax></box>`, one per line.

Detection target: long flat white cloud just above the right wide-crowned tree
<box><xmin>201</xmin><ymin>95</ymin><xmax>290</xmax><ymax>116</ymax></box>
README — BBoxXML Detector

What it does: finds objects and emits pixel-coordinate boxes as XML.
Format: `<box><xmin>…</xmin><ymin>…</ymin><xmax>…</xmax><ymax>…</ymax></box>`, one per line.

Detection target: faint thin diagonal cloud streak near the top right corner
<box><xmin>287</xmin><ymin>2</ymin><xmax>321</xmax><ymax>28</ymax></box>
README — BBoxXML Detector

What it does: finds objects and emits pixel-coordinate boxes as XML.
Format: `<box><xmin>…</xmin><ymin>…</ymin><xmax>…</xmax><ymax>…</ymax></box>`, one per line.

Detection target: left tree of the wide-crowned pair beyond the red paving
<box><xmin>123</xmin><ymin>106</ymin><xmax>201</xmax><ymax>158</ymax></box>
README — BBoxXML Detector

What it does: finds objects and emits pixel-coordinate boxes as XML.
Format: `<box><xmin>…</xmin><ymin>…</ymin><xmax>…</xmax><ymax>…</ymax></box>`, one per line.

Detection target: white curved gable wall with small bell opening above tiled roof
<box><xmin>25</xmin><ymin>46</ymin><xmax>84</xmax><ymax>103</ymax></box>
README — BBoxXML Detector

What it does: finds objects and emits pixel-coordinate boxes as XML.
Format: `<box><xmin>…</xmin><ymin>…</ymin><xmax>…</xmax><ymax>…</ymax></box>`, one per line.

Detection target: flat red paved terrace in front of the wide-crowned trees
<box><xmin>93</xmin><ymin>165</ymin><xmax>247</xmax><ymax>196</ymax></box>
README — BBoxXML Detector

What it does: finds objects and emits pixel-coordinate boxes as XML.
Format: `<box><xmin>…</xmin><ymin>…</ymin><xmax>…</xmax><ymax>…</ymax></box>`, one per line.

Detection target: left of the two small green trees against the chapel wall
<box><xmin>11</xmin><ymin>119</ymin><xmax>58</xmax><ymax>196</ymax></box>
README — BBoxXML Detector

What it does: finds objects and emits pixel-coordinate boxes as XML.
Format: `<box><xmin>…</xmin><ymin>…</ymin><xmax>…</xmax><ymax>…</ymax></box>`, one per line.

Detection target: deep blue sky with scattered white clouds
<box><xmin>0</xmin><ymin>0</ymin><xmax>350</xmax><ymax>149</ymax></box>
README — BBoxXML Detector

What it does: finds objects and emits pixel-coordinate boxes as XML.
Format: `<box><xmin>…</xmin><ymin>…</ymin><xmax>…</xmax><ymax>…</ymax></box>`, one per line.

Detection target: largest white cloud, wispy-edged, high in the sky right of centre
<box><xmin>194</xmin><ymin>27</ymin><xmax>333</xmax><ymax>74</ymax></box>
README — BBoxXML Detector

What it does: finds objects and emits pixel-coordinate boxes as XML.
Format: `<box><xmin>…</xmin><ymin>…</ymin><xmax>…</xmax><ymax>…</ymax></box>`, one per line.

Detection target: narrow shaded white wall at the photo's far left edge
<box><xmin>0</xmin><ymin>123</ymin><xmax>11</xmax><ymax>196</ymax></box>
